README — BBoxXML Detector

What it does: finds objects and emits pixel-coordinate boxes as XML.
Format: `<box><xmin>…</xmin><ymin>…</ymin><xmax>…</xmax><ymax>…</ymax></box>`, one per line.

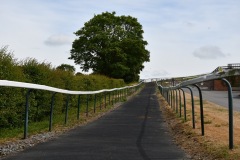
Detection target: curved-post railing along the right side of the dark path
<box><xmin>157</xmin><ymin>67</ymin><xmax>240</xmax><ymax>149</ymax></box>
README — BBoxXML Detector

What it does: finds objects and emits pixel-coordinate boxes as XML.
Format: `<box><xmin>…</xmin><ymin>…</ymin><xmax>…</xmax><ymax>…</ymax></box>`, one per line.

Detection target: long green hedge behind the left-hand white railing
<box><xmin>0</xmin><ymin>47</ymin><xmax>125</xmax><ymax>128</ymax></box>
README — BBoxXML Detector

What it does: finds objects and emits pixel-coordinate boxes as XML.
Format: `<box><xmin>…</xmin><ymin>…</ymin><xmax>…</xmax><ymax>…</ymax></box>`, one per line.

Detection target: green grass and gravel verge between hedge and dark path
<box><xmin>0</xmin><ymin>86</ymin><xmax>143</xmax><ymax>145</ymax></box>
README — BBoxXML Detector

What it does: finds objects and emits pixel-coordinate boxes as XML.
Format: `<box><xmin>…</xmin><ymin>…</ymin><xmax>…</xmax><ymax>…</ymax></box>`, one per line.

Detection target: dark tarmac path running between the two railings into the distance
<box><xmin>3</xmin><ymin>83</ymin><xmax>187</xmax><ymax>160</ymax></box>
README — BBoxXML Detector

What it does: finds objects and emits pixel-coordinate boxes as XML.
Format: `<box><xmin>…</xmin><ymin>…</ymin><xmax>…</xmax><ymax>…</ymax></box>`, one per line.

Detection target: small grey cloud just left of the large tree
<box><xmin>44</xmin><ymin>35</ymin><xmax>73</xmax><ymax>46</ymax></box>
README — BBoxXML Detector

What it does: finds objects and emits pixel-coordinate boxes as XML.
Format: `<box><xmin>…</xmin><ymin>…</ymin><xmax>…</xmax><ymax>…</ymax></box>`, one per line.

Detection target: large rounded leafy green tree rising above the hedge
<box><xmin>69</xmin><ymin>12</ymin><xmax>150</xmax><ymax>82</ymax></box>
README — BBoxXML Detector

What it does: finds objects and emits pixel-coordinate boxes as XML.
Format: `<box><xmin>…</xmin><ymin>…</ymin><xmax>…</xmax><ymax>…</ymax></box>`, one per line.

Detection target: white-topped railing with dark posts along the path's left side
<box><xmin>0</xmin><ymin>80</ymin><xmax>143</xmax><ymax>139</ymax></box>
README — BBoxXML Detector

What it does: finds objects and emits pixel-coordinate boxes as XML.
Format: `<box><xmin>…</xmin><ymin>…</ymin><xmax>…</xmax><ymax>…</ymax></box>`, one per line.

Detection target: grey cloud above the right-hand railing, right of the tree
<box><xmin>193</xmin><ymin>45</ymin><xmax>228</xmax><ymax>59</ymax></box>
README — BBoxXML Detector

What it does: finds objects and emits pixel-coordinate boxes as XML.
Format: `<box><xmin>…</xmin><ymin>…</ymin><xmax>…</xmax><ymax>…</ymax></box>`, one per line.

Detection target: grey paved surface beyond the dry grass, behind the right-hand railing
<box><xmin>184</xmin><ymin>87</ymin><xmax>240</xmax><ymax>111</ymax></box>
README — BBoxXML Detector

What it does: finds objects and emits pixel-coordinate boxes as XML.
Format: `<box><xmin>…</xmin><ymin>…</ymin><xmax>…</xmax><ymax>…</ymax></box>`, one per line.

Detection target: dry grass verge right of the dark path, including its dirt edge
<box><xmin>158</xmin><ymin>90</ymin><xmax>240</xmax><ymax>160</ymax></box>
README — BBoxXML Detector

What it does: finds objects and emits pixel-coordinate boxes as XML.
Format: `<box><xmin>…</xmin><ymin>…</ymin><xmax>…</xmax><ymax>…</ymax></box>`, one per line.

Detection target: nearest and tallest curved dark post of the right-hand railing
<box><xmin>222</xmin><ymin>78</ymin><xmax>233</xmax><ymax>149</ymax></box>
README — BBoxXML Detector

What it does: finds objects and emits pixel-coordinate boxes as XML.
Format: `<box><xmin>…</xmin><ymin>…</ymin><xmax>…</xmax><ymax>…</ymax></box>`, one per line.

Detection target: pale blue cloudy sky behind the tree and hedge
<box><xmin>0</xmin><ymin>0</ymin><xmax>240</xmax><ymax>78</ymax></box>
